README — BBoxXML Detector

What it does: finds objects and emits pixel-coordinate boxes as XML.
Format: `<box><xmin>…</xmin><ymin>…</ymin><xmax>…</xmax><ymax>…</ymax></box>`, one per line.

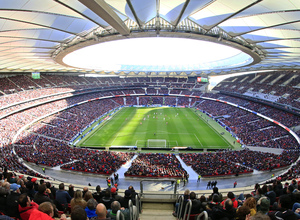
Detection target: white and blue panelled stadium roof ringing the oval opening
<box><xmin>0</xmin><ymin>0</ymin><xmax>300</xmax><ymax>76</ymax></box>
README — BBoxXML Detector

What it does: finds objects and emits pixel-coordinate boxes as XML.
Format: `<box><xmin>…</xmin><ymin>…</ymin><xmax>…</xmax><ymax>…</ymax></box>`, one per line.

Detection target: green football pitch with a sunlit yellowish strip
<box><xmin>77</xmin><ymin>107</ymin><xmax>239</xmax><ymax>149</ymax></box>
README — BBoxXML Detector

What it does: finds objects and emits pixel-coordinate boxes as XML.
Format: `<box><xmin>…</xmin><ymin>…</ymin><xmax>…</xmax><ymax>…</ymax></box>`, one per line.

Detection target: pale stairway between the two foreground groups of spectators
<box><xmin>140</xmin><ymin>202</ymin><xmax>176</xmax><ymax>220</ymax></box>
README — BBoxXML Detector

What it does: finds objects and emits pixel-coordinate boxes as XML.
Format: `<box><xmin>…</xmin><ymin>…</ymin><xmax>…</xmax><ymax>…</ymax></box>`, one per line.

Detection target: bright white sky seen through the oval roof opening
<box><xmin>63</xmin><ymin>37</ymin><xmax>251</xmax><ymax>71</ymax></box>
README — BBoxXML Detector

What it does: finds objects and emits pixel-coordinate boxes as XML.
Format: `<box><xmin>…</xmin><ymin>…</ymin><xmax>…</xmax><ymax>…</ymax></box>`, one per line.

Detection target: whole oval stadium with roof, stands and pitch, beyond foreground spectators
<box><xmin>0</xmin><ymin>0</ymin><xmax>300</xmax><ymax>219</ymax></box>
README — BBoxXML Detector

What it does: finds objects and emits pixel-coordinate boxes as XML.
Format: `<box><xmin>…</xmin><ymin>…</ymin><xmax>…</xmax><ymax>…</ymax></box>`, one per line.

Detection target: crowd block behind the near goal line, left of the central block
<box><xmin>15</xmin><ymin>137</ymin><xmax>134</xmax><ymax>174</ymax></box>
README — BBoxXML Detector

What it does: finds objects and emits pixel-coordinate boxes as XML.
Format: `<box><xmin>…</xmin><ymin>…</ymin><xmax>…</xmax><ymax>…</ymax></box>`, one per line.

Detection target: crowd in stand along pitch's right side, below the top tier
<box><xmin>196</xmin><ymin>94</ymin><xmax>300</xmax><ymax>149</ymax></box>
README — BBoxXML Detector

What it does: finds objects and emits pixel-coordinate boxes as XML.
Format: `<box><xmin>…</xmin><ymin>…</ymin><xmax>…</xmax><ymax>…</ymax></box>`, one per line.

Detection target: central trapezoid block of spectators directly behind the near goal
<box><xmin>124</xmin><ymin>153</ymin><xmax>188</xmax><ymax>178</ymax></box>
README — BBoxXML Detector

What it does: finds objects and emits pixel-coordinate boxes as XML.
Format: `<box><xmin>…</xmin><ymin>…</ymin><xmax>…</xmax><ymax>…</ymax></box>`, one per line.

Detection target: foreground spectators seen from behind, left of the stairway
<box><xmin>0</xmin><ymin>170</ymin><xmax>137</xmax><ymax>220</ymax></box>
